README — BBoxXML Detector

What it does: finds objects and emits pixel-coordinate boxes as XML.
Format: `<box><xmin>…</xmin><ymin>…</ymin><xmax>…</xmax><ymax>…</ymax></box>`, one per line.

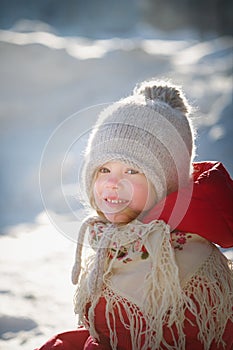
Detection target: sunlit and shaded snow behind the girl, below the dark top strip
<box><xmin>0</xmin><ymin>22</ymin><xmax>233</xmax><ymax>350</ymax></box>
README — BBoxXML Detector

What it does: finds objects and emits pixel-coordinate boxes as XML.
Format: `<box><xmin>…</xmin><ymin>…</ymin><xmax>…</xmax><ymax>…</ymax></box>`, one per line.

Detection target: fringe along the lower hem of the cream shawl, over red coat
<box><xmin>99</xmin><ymin>247</ymin><xmax>233</xmax><ymax>350</ymax></box>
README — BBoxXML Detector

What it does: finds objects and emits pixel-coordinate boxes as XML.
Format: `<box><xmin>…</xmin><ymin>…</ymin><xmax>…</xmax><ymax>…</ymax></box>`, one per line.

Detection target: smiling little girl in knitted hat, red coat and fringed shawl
<box><xmin>36</xmin><ymin>80</ymin><xmax>233</xmax><ymax>350</ymax></box>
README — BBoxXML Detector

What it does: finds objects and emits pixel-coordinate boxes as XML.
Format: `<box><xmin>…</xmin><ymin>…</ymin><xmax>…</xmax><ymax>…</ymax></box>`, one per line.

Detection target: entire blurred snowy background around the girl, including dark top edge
<box><xmin>0</xmin><ymin>0</ymin><xmax>233</xmax><ymax>350</ymax></box>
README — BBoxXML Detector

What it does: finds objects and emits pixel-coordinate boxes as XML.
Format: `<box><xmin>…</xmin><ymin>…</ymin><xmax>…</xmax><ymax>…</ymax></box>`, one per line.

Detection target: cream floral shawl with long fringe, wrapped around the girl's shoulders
<box><xmin>72</xmin><ymin>217</ymin><xmax>233</xmax><ymax>350</ymax></box>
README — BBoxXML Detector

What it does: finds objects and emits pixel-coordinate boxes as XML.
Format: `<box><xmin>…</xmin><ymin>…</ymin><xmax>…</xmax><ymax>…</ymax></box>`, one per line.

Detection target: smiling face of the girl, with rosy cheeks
<box><xmin>94</xmin><ymin>161</ymin><xmax>156</xmax><ymax>223</ymax></box>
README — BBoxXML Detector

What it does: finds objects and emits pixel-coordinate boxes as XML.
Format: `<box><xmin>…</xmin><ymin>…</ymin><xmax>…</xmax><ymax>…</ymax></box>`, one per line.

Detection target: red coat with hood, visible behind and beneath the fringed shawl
<box><xmin>35</xmin><ymin>162</ymin><xmax>233</xmax><ymax>350</ymax></box>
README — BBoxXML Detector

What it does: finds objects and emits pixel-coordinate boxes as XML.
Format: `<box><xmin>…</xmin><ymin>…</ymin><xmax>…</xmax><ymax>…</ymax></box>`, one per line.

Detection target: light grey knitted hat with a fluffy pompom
<box><xmin>82</xmin><ymin>80</ymin><xmax>194</xmax><ymax>208</ymax></box>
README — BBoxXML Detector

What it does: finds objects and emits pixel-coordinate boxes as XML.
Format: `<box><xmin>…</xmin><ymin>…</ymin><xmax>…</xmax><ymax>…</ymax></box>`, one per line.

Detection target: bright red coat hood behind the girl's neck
<box><xmin>143</xmin><ymin>162</ymin><xmax>233</xmax><ymax>248</ymax></box>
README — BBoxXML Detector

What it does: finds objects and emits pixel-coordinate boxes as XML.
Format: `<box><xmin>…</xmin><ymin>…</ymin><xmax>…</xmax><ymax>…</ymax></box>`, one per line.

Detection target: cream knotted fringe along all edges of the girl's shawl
<box><xmin>74</xmin><ymin>220</ymin><xmax>233</xmax><ymax>350</ymax></box>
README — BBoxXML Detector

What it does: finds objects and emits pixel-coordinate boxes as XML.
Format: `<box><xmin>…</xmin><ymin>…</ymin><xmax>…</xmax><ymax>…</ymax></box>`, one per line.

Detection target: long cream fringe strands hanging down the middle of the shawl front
<box><xmin>140</xmin><ymin>226</ymin><xmax>195</xmax><ymax>349</ymax></box>
